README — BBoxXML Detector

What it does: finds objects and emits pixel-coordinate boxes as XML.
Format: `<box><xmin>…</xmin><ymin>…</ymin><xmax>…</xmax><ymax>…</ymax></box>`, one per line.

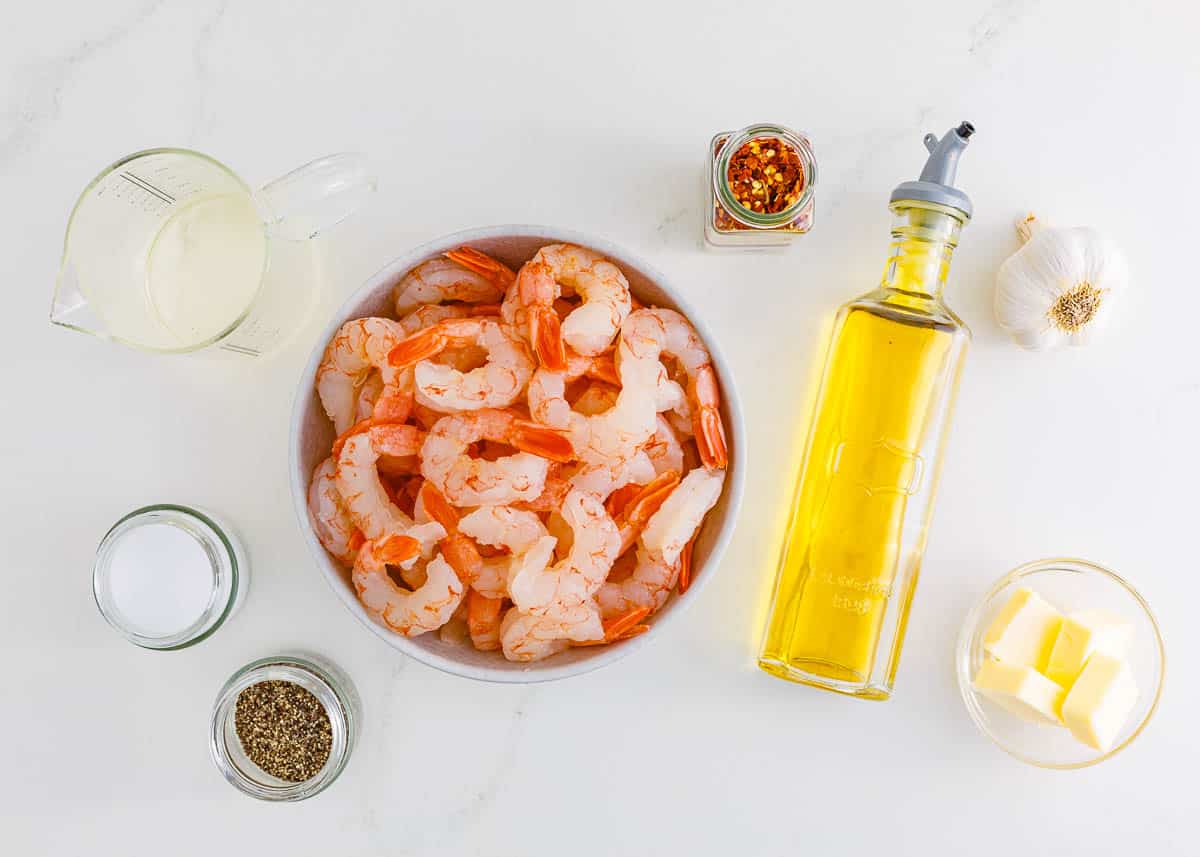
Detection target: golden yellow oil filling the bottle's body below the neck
<box><xmin>760</xmin><ymin>304</ymin><xmax>959</xmax><ymax>696</ymax></box>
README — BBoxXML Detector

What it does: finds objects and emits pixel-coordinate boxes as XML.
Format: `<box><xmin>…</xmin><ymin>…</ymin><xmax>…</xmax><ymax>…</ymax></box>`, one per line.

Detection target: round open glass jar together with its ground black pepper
<box><xmin>209</xmin><ymin>654</ymin><xmax>361</xmax><ymax>801</ymax></box>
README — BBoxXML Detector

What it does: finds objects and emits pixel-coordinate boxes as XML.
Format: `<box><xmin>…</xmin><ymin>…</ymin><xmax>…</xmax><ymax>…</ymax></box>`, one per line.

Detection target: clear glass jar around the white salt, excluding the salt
<box><xmin>91</xmin><ymin>503</ymin><xmax>244</xmax><ymax>652</ymax></box>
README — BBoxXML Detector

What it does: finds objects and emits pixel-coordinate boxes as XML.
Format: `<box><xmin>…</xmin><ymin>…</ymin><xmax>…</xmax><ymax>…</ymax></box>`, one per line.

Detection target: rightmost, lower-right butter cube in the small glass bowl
<box><xmin>1062</xmin><ymin>653</ymin><xmax>1138</xmax><ymax>753</ymax></box>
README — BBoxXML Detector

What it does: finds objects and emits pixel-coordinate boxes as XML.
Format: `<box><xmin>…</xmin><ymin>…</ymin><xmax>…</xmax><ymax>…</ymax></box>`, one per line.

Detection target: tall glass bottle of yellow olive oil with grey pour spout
<box><xmin>758</xmin><ymin>122</ymin><xmax>974</xmax><ymax>700</ymax></box>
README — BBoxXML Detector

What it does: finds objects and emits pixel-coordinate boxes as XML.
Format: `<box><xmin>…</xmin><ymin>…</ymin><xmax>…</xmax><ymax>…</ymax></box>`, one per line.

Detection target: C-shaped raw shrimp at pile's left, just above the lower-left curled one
<box><xmin>335</xmin><ymin>425</ymin><xmax>445</xmax><ymax>551</ymax></box>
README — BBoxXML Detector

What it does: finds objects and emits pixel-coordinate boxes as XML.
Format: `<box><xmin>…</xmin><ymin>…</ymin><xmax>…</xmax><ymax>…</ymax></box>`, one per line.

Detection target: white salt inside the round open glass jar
<box><xmin>108</xmin><ymin>523</ymin><xmax>214</xmax><ymax>636</ymax></box>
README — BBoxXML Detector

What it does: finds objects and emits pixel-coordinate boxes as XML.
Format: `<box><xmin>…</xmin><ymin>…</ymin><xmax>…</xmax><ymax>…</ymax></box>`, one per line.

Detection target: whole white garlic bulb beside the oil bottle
<box><xmin>996</xmin><ymin>215</ymin><xmax>1128</xmax><ymax>350</ymax></box>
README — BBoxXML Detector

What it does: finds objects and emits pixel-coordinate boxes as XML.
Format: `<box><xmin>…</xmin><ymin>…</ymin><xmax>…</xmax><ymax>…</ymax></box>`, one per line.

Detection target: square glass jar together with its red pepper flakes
<box><xmin>704</xmin><ymin>124</ymin><xmax>817</xmax><ymax>250</ymax></box>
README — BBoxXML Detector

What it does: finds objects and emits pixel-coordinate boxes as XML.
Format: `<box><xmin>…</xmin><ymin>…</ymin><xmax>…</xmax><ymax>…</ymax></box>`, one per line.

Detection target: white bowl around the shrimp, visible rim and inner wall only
<box><xmin>288</xmin><ymin>226</ymin><xmax>746</xmax><ymax>683</ymax></box>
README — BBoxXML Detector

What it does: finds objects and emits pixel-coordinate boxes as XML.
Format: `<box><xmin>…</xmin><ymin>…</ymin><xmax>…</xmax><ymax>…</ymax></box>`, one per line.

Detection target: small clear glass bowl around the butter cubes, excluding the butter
<box><xmin>954</xmin><ymin>558</ymin><xmax>1166</xmax><ymax>769</ymax></box>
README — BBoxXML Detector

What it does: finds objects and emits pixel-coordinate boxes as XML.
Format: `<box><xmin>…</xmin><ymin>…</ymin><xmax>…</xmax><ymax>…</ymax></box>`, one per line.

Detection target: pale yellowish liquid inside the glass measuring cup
<box><xmin>143</xmin><ymin>193</ymin><xmax>266</xmax><ymax>348</ymax></box>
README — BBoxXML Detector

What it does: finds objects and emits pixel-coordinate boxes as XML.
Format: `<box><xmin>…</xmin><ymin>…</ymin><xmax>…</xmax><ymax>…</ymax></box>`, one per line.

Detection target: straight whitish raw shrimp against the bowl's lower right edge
<box><xmin>596</xmin><ymin>469</ymin><xmax>725</xmax><ymax>618</ymax></box>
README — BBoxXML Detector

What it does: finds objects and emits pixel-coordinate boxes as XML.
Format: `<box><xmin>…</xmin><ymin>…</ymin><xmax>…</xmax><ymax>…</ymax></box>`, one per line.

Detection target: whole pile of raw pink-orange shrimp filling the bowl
<box><xmin>308</xmin><ymin>244</ymin><xmax>728</xmax><ymax>661</ymax></box>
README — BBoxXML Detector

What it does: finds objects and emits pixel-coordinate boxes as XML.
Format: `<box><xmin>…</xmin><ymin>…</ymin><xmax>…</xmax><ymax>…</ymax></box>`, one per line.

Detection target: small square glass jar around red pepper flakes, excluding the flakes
<box><xmin>704</xmin><ymin>124</ymin><xmax>817</xmax><ymax>250</ymax></box>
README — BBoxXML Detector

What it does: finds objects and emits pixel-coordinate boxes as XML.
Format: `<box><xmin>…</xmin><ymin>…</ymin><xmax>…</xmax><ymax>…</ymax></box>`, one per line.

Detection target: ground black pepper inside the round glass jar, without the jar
<box><xmin>234</xmin><ymin>681</ymin><xmax>334</xmax><ymax>783</ymax></box>
